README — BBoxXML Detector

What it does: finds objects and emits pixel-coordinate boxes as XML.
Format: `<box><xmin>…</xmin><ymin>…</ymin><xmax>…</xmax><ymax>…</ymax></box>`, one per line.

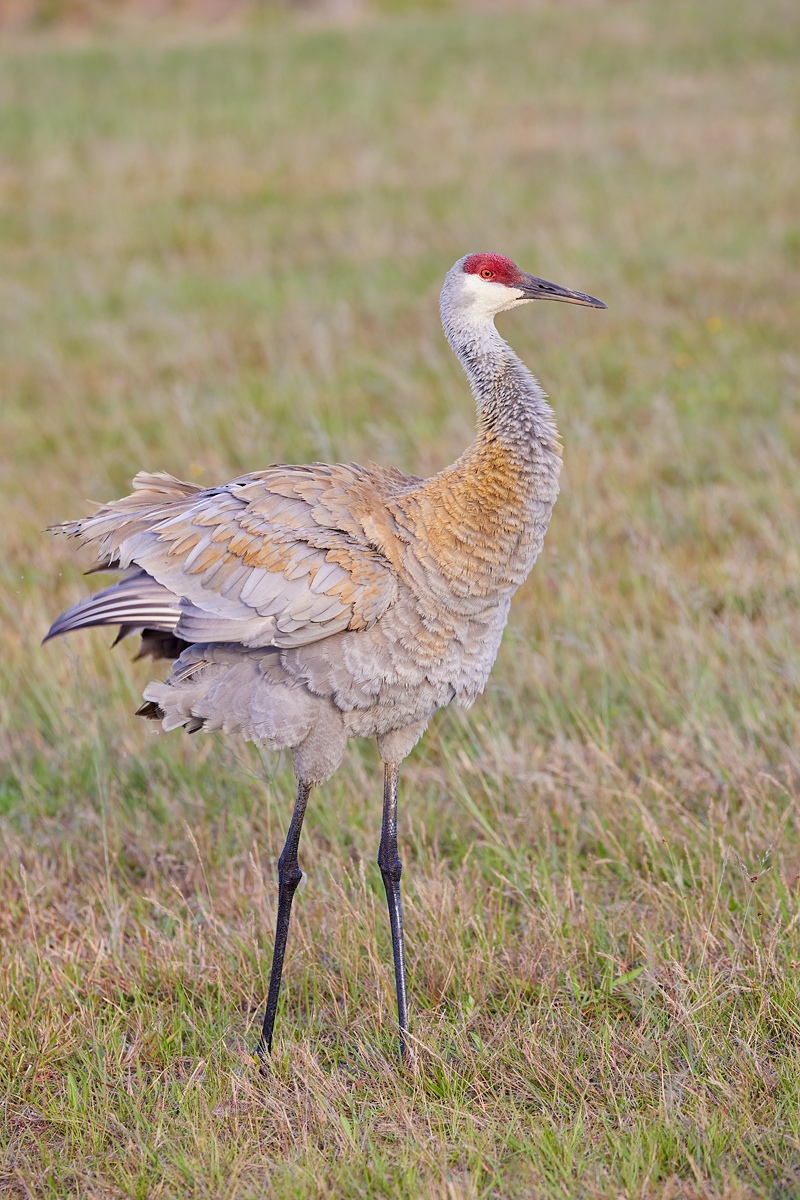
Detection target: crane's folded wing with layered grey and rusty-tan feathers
<box><xmin>52</xmin><ymin>463</ymin><xmax>407</xmax><ymax>647</ymax></box>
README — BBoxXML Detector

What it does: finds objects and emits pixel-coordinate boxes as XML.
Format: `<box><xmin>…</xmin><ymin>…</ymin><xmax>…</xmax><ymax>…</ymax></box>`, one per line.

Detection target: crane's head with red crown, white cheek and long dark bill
<box><xmin>441</xmin><ymin>254</ymin><xmax>606</xmax><ymax>319</ymax></box>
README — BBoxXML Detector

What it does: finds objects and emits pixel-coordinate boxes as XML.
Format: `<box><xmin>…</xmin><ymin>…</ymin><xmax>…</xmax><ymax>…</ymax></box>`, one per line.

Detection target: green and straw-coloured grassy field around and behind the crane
<box><xmin>0</xmin><ymin>0</ymin><xmax>800</xmax><ymax>1200</ymax></box>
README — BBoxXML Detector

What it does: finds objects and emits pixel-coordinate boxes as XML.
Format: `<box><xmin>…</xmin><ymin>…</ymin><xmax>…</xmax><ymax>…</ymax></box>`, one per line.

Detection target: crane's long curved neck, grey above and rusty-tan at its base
<box><xmin>400</xmin><ymin>304</ymin><xmax>561</xmax><ymax>596</ymax></box>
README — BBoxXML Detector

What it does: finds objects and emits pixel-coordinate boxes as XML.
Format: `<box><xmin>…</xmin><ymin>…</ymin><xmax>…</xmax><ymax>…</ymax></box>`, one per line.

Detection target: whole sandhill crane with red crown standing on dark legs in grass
<box><xmin>47</xmin><ymin>254</ymin><xmax>606</xmax><ymax>1057</ymax></box>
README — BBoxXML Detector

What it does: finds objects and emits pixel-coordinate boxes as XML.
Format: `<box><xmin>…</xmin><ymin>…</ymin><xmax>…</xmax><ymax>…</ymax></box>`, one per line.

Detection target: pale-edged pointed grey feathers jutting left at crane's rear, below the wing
<box><xmin>44</xmin><ymin>571</ymin><xmax>186</xmax><ymax>654</ymax></box>
